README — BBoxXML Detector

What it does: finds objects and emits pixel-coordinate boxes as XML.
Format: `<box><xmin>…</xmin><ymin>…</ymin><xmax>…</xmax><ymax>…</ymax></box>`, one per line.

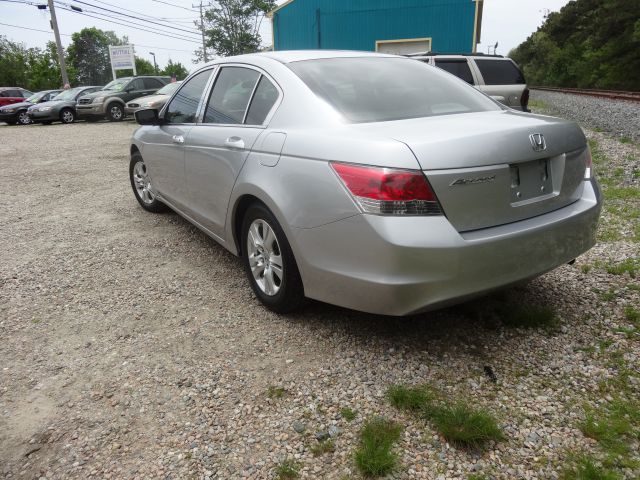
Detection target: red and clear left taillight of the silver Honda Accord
<box><xmin>331</xmin><ymin>163</ymin><xmax>442</xmax><ymax>215</ymax></box>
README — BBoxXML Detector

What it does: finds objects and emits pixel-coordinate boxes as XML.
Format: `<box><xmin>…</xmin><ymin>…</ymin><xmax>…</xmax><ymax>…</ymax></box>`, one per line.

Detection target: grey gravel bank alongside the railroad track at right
<box><xmin>531</xmin><ymin>90</ymin><xmax>640</xmax><ymax>142</ymax></box>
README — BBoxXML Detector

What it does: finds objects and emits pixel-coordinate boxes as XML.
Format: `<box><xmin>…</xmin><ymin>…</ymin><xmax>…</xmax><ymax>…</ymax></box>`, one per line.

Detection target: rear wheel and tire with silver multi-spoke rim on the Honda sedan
<box><xmin>240</xmin><ymin>203</ymin><xmax>305</xmax><ymax>313</ymax></box>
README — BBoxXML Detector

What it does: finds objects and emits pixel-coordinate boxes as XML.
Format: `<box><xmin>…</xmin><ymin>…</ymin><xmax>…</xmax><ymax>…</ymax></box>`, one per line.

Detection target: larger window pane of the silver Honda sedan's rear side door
<box><xmin>204</xmin><ymin>67</ymin><xmax>260</xmax><ymax>124</ymax></box>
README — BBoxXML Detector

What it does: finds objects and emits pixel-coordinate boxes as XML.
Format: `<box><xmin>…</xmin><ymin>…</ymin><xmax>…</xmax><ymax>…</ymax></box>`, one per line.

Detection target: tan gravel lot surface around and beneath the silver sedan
<box><xmin>0</xmin><ymin>116</ymin><xmax>640</xmax><ymax>480</ymax></box>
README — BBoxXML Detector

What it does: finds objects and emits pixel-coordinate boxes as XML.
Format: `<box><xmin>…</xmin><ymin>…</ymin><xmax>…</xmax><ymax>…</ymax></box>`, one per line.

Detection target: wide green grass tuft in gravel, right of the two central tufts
<box><xmin>430</xmin><ymin>403</ymin><xmax>505</xmax><ymax>448</ymax></box>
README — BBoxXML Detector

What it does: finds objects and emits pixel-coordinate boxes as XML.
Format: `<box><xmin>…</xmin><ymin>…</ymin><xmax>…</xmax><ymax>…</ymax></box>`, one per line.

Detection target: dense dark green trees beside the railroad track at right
<box><xmin>509</xmin><ymin>0</ymin><xmax>640</xmax><ymax>91</ymax></box>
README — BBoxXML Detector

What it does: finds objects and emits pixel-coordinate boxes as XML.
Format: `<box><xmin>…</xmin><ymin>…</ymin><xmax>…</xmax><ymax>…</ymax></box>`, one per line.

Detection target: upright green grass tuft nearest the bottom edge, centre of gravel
<box><xmin>355</xmin><ymin>417</ymin><xmax>402</xmax><ymax>477</ymax></box>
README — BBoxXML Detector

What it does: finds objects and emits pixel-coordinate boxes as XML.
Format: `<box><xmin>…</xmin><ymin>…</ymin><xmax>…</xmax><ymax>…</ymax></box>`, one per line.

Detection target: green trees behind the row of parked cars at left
<box><xmin>0</xmin><ymin>27</ymin><xmax>189</xmax><ymax>91</ymax></box>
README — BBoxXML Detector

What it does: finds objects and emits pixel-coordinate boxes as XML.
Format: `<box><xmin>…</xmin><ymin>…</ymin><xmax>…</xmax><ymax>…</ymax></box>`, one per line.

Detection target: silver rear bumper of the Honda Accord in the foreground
<box><xmin>291</xmin><ymin>180</ymin><xmax>602</xmax><ymax>316</ymax></box>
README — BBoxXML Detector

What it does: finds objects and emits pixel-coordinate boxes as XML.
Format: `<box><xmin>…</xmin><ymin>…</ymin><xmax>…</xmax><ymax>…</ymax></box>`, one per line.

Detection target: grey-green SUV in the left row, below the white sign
<box><xmin>76</xmin><ymin>76</ymin><xmax>171</xmax><ymax>122</ymax></box>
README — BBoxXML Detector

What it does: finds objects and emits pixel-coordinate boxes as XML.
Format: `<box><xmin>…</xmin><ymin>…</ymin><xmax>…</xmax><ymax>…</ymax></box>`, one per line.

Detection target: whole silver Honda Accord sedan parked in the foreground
<box><xmin>129</xmin><ymin>51</ymin><xmax>601</xmax><ymax>315</ymax></box>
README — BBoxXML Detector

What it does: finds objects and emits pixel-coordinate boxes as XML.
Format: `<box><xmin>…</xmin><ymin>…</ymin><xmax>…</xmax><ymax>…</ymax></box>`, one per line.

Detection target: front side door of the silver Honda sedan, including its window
<box><xmin>142</xmin><ymin>69</ymin><xmax>212</xmax><ymax>211</ymax></box>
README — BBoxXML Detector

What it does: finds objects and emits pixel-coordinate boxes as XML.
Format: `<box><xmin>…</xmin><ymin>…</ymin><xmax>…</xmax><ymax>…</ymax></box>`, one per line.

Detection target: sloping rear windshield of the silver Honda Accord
<box><xmin>289</xmin><ymin>57</ymin><xmax>500</xmax><ymax>123</ymax></box>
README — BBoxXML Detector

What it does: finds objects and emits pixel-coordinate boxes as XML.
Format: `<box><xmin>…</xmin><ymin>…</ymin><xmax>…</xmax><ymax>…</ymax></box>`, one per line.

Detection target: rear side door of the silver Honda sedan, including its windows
<box><xmin>185</xmin><ymin>65</ymin><xmax>280</xmax><ymax>238</ymax></box>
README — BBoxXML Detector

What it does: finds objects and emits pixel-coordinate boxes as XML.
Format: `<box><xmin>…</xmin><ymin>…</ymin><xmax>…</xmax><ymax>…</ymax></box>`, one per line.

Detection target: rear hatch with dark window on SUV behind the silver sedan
<box><xmin>472</xmin><ymin>58</ymin><xmax>527</xmax><ymax>110</ymax></box>
